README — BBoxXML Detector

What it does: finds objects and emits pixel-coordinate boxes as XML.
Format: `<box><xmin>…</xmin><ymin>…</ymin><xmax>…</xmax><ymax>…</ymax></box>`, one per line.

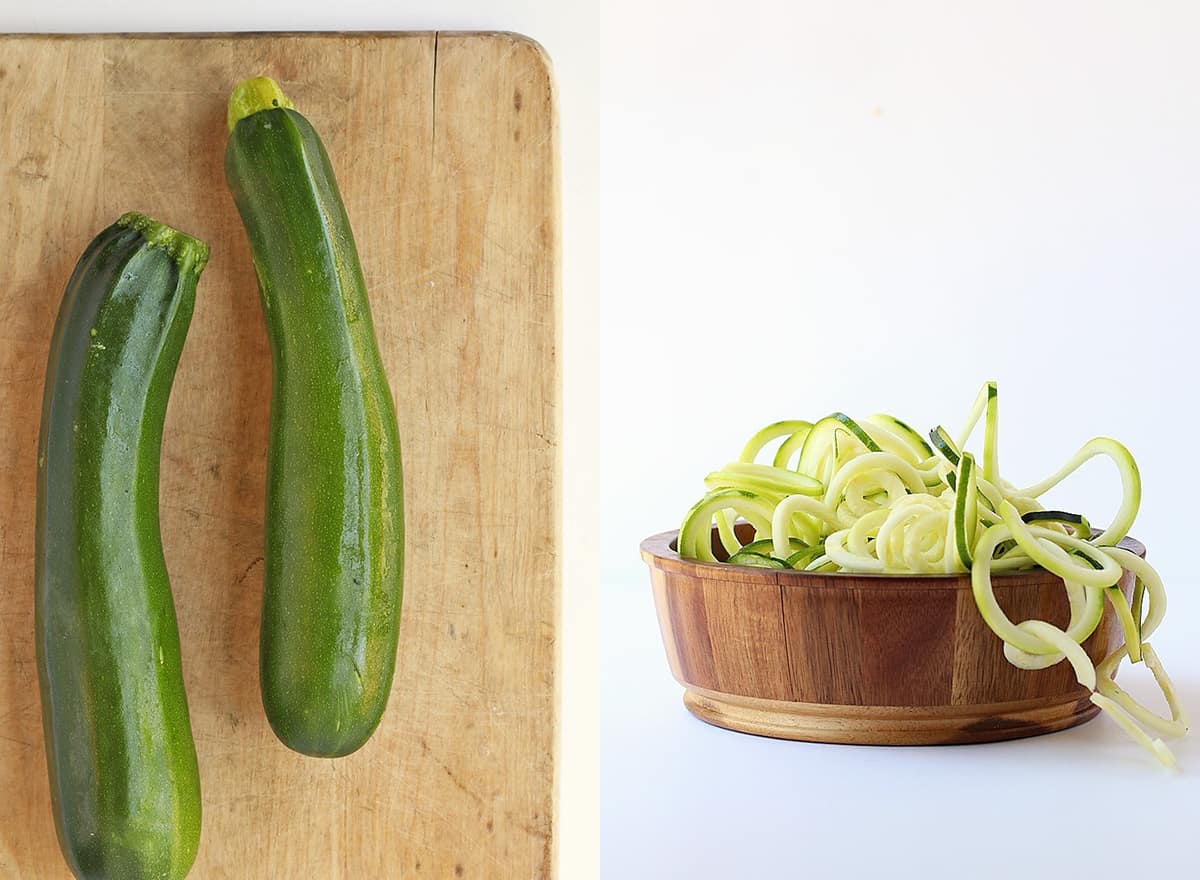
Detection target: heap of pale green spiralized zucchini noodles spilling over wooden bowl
<box><xmin>678</xmin><ymin>382</ymin><xmax>1188</xmax><ymax>766</ymax></box>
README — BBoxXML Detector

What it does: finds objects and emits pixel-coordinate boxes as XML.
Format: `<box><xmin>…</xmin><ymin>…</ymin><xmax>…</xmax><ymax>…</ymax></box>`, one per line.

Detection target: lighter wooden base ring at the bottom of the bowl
<box><xmin>683</xmin><ymin>688</ymin><xmax>1100</xmax><ymax>746</ymax></box>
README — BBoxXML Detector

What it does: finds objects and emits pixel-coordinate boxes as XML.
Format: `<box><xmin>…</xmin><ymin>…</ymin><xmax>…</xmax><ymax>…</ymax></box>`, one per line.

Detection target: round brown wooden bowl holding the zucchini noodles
<box><xmin>641</xmin><ymin>523</ymin><xmax>1146</xmax><ymax>746</ymax></box>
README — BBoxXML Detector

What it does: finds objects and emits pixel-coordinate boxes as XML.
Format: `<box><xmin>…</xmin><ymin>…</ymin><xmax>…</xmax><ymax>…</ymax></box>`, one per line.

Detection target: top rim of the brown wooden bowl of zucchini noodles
<box><xmin>638</xmin><ymin>527</ymin><xmax>1146</xmax><ymax>589</ymax></box>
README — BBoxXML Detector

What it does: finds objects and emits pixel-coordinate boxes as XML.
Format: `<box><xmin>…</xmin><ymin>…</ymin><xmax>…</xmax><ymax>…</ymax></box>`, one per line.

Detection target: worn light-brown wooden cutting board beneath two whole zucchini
<box><xmin>0</xmin><ymin>34</ymin><xmax>559</xmax><ymax>880</ymax></box>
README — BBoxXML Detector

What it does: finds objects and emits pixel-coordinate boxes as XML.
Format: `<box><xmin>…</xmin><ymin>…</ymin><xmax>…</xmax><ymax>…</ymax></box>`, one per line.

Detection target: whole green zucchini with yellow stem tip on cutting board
<box><xmin>226</xmin><ymin>80</ymin><xmax>404</xmax><ymax>758</ymax></box>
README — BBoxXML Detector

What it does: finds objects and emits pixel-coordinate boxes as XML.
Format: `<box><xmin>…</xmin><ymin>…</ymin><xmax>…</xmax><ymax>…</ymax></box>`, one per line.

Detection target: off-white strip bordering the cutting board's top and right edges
<box><xmin>0</xmin><ymin>0</ymin><xmax>606</xmax><ymax>880</ymax></box>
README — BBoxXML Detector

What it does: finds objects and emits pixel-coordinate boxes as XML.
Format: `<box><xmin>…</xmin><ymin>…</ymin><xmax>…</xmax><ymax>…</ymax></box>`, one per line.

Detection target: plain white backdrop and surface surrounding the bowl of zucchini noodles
<box><xmin>600</xmin><ymin>0</ymin><xmax>1200</xmax><ymax>880</ymax></box>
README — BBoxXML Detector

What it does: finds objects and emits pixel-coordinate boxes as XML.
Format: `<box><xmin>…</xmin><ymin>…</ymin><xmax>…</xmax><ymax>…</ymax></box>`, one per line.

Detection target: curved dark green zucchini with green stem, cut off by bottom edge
<box><xmin>35</xmin><ymin>215</ymin><xmax>208</xmax><ymax>880</ymax></box>
